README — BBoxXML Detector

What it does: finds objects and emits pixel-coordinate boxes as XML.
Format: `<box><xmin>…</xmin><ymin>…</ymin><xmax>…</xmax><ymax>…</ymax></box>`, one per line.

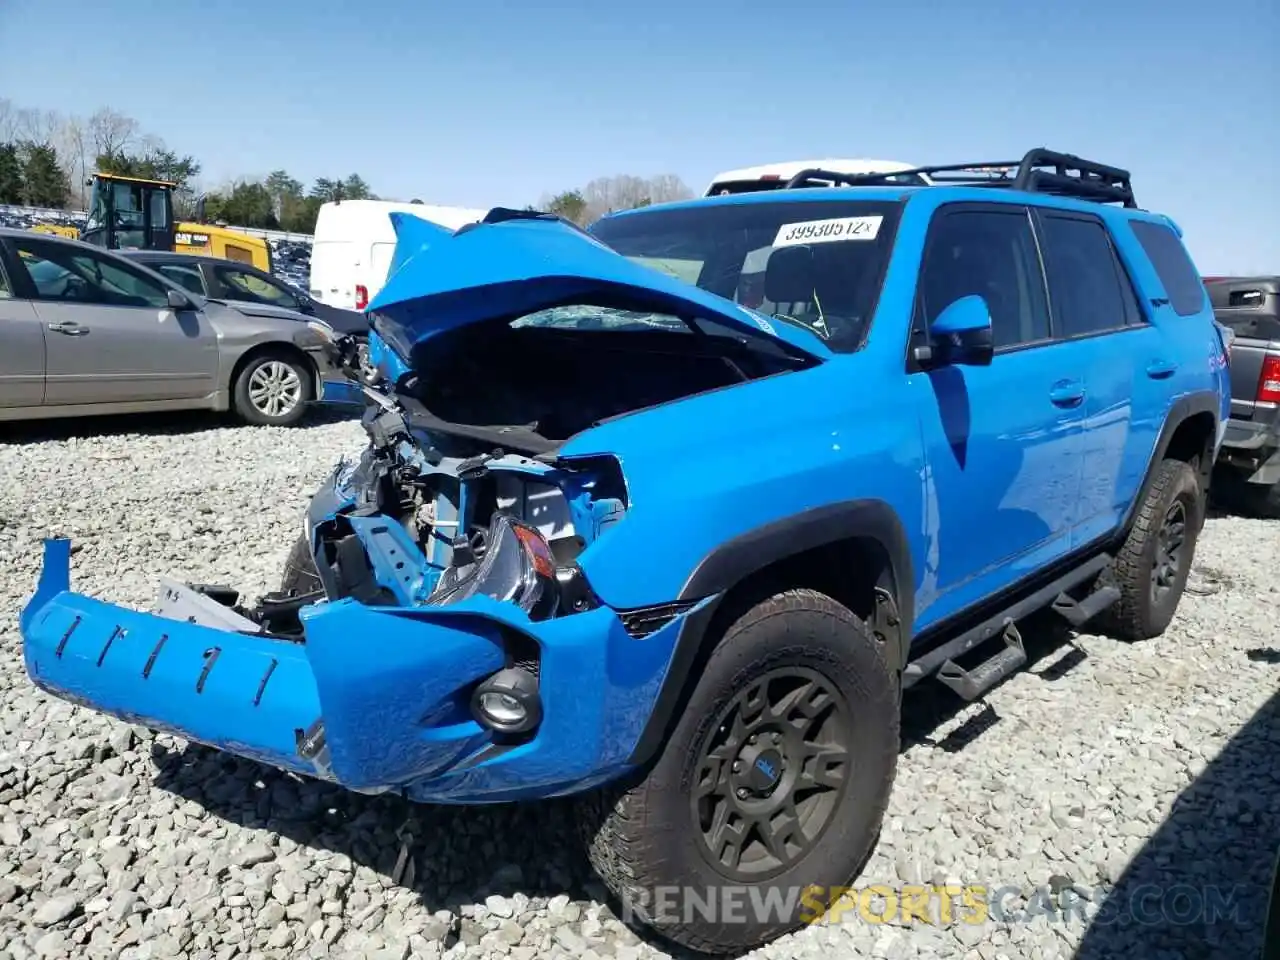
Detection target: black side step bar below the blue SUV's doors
<box><xmin>902</xmin><ymin>553</ymin><xmax>1120</xmax><ymax>696</ymax></box>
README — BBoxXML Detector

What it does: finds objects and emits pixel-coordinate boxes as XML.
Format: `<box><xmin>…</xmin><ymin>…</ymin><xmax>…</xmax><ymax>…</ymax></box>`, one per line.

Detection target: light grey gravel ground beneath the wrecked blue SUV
<box><xmin>0</xmin><ymin>417</ymin><xmax>1280</xmax><ymax>960</ymax></box>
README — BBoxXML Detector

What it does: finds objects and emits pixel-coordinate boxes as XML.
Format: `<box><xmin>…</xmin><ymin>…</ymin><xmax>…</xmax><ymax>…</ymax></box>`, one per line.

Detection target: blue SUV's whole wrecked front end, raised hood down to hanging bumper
<box><xmin>22</xmin><ymin>211</ymin><xmax>826</xmax><ymax>803</ymax></box>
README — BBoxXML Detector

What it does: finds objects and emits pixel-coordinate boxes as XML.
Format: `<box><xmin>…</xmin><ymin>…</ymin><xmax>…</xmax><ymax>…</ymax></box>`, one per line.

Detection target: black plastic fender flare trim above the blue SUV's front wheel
<box><xmin>628</xmin><ymin>499</ymin><xmax>915</xmax><ymax>765</ymax></box>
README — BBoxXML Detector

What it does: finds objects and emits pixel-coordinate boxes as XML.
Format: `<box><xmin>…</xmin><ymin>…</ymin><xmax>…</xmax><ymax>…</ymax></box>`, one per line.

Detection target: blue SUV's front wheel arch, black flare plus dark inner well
<box><xmin>628</xmin><ymin>499</ymin><xmax>915</xmax><ymax>765</ymax></box>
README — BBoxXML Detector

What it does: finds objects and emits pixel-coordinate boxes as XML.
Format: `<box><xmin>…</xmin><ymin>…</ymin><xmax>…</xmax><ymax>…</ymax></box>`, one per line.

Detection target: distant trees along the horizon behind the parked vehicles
<box><xmin>0</xmin><ymin>99</ymin><xmax>692</xmax><ymax>233</ymax></box>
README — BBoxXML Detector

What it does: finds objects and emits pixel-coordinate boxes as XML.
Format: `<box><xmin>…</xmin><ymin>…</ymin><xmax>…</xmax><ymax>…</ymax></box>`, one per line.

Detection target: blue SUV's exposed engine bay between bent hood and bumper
<box><xmin>231</xmin><ymin>308</ymin><xmax>805</xmax><ymax>636</ymax></box>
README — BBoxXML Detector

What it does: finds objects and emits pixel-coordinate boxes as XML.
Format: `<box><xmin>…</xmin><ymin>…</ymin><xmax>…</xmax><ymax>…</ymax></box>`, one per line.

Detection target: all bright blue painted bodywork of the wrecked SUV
<box><xmin>22</xmin><ymin>180</ymin><xmax>1230</xmax><ymax>803</ymax></box>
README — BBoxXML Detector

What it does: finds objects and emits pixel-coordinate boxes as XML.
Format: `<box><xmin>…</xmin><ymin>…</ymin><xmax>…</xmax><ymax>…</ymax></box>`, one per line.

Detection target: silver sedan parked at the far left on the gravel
<box><xmin>0</xmin><ymin>229</ymin><xmax>364</xmax><ymax>425</ymax></box>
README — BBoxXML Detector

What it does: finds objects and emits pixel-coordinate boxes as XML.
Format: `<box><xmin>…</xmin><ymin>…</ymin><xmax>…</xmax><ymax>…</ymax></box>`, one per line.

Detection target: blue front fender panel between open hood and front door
<box><xmin>564</xmin><ymin>357</ymin><xmax>924</xmax><ymax>609</ymax></box>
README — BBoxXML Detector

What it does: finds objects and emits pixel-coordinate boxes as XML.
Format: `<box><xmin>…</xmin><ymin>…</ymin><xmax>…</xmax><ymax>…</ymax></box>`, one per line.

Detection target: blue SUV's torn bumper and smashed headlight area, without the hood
<box><xmin>22</xmin><ymin>411</ymin><xmax>701</xmax><ymax>803</ymax></box>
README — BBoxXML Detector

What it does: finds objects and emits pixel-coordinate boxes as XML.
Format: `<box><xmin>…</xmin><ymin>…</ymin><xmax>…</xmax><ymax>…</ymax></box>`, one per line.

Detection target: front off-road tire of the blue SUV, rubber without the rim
<box><xmin>579</xmin><ymin>589</ymin><xmax>900</xmax><ymax>954</ymax></box>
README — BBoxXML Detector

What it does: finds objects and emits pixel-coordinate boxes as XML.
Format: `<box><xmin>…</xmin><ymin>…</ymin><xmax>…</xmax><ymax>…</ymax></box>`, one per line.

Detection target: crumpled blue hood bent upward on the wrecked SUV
<box><xmin>369</xmin><ymin>207</ymin><xmax>832</xmax><ymax>360</ymax></box>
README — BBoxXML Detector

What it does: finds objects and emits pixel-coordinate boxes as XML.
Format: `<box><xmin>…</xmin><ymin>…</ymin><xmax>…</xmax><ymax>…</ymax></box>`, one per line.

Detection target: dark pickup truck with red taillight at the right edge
<box><xmin>1204</xmin><ymin>276</ymin><xmax>1280</xmax><ymax>517</ymax></box>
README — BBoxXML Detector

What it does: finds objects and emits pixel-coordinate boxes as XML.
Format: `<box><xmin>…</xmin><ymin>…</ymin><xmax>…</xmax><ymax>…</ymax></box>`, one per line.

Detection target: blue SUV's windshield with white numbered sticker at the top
<box><xmin>591</xmin><ymin>200</ymin><xmax>901</xmax><ymax>351</ymax></box>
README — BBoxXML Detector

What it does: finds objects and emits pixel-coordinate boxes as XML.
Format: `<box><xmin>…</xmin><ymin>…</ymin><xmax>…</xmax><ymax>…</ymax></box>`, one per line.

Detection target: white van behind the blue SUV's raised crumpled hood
<box><xmin>307</xmin><ymin>200</ymin><xmax>489</xmax><ymax>310</ymax></box>
